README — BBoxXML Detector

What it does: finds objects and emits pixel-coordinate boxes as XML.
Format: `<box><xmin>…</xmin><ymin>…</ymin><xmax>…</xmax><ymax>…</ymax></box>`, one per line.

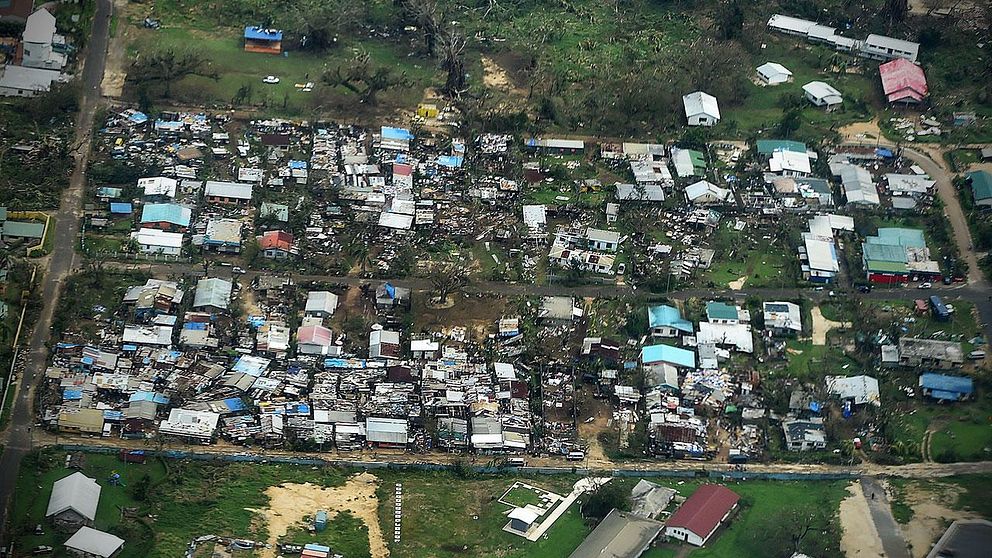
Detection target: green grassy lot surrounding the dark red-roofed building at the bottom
<box><xmin>372</xmin><ymin>473</ymin><xmax>845</xmax><ymax>558</ymax></box>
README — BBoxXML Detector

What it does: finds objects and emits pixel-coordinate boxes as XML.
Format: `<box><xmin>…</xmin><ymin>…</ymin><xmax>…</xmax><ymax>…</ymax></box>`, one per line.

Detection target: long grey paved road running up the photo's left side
<box><xmin>0</xmin><ymin>0</ymin><xmax>111</xmax><ymax>547</ymax></box>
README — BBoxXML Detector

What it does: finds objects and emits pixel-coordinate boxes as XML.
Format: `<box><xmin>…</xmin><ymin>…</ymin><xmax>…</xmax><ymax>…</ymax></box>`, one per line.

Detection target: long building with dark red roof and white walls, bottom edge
<box><xmin>665</xmin><ymin>484</ymin><xmax>740</xmax><ymax>546</ymax></box>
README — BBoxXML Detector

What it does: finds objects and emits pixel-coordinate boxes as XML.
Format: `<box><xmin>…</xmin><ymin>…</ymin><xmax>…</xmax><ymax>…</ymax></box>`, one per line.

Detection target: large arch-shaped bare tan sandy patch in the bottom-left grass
<box><xmin>252</xmin><ymin>473</ymin><xmax>389</xmax><ymax>558</ymax></box>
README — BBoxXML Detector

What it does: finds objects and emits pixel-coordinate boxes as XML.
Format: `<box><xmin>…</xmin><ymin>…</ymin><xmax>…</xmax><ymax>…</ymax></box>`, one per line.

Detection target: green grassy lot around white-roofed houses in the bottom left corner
<box><xmin>12</xmin><ymin>451</ymin><xmax>352</xmax><ymax>558</ymax></box>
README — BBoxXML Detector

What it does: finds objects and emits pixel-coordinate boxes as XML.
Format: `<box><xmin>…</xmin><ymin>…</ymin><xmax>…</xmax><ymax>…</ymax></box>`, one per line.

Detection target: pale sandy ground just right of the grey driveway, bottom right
<box><xmin>900</xmin><ymin>483</ymin><xmax>977</xmax><ymax>558</ymax></box>
